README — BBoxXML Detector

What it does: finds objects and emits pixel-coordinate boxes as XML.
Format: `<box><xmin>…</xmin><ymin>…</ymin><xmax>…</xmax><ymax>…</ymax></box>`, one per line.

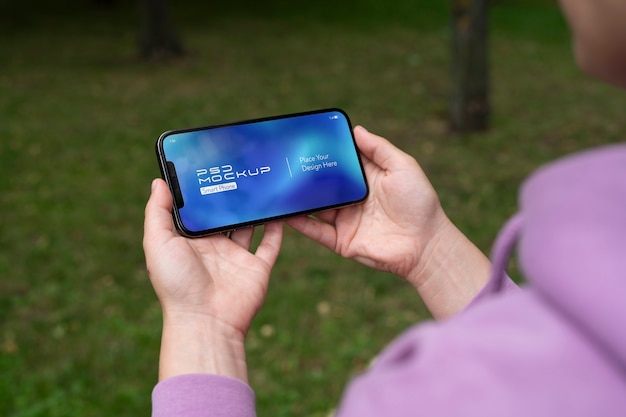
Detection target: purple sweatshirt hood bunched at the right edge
<box><xmin>517</xmin><ymin>145</ymin><xmax>626</xmax><ymax>367</ymax></box>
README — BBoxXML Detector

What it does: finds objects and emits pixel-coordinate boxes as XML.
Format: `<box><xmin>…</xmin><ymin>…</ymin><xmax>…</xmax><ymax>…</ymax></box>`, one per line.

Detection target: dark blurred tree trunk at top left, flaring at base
<box><xmin>139</xmin><ymin>0</ymin><xmax>185</xmax><ymax>59</ymax></box>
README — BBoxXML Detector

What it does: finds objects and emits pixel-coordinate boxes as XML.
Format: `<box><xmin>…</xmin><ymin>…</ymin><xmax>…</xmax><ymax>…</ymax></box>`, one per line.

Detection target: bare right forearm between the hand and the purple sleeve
<box><xmin>406</xmin><ymin>220</ymin><xmax>491</xmax><ymax>319</ymax></box>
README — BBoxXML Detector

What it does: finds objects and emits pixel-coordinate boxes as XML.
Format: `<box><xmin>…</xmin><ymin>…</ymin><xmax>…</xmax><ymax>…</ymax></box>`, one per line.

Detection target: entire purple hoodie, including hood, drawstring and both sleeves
<box><xmin>152</xmin><ymin>145</ymin><xmax>626</xmax><ymax>417</ymax></box>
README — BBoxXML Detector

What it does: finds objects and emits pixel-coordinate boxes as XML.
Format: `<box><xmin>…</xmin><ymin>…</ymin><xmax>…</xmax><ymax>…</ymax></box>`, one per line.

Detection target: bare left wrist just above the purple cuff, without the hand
<box><xmin>159</xmin><ymin>313</ymin><xmax>248</xmax><ymax>383</ymax></box>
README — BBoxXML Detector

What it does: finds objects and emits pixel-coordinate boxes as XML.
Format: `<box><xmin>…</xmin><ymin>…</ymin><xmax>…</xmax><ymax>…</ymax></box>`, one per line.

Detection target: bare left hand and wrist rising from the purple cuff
<box><xmin>143</xmin><ymin>179</ymin><xmax>282</xmax><ymax>381</ymax></box>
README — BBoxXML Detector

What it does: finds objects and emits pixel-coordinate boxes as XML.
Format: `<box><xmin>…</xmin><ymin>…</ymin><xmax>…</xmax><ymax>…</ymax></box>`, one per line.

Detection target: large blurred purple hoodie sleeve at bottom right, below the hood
<box><xmin>336</xmin><ymin>290</ymin><xmax>626</xmax><ymax>417</ymax></box>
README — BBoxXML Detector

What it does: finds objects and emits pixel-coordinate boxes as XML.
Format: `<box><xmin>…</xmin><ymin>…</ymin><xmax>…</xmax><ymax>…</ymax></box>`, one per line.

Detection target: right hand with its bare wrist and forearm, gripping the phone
<box><xmin>286</xmin><ymin>126</ymin><xmax>489</xmax><ymax>317</ymax></box>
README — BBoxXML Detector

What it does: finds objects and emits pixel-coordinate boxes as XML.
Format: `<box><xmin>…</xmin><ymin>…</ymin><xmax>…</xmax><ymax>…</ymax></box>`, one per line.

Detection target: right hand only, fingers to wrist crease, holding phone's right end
<box><xmin>286</xmin><ymin>126</ymin><xmax>447</xmax><ymax>277</ymax></box>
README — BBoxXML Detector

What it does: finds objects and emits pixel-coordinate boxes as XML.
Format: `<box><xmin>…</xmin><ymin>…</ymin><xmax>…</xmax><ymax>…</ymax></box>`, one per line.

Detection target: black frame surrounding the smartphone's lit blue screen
<box><xmin>155</xmin><ymin>108</ymin><xmax>369</xmax><ymax>238</ymax></box>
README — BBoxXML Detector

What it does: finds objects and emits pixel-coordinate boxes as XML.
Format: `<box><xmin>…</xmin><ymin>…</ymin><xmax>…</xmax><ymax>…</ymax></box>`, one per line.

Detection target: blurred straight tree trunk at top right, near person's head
<box><xmin>450</xmin><ymin>0</ymin><xmax>490</xmax><ymax>132</ymax></box>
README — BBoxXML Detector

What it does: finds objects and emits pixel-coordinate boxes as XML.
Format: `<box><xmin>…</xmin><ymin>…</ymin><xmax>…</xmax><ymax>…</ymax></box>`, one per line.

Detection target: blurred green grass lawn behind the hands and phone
<box><xmin>0</xmin><ymin>0</ymin><xmax>626</xmax><ymax>417</ymax></box>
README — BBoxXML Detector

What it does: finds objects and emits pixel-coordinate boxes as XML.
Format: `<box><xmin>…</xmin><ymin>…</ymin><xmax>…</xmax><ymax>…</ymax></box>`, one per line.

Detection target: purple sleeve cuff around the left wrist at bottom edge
<box><xmin>152</xmin><ymin>374</ymin><xmax>256</xmax><ymax>417</ymax></box>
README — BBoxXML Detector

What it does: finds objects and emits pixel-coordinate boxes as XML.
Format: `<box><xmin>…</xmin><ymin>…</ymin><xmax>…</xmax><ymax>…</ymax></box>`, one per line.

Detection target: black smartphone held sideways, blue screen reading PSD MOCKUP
<box><xmin>156</xmin><ymin>109</ymin><xmax>368</xmax><ymax>237</ymax></box>
